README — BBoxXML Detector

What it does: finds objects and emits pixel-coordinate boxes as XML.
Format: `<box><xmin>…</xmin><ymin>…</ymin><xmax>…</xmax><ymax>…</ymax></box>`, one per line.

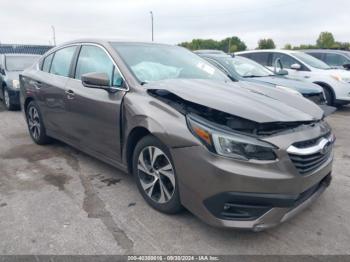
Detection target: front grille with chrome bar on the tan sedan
<box><xmin>287</xmin><ymin>134</ymin><xmax>335</xmax><ymax>175</ymax></box>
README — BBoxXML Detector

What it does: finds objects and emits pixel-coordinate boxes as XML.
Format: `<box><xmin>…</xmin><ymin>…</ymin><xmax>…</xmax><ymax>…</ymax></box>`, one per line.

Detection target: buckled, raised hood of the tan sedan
<box><xmin>145</xmin><ymin>79</ymin><xmax>323</xmax><ymax>123</ymax></box>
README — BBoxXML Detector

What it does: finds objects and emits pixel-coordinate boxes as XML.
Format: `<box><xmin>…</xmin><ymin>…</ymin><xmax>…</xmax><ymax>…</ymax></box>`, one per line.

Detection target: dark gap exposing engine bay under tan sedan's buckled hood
<box><xmin>148</xmin><ymin>89</ymin><xmax>320</xmax><ymax>136</ymax></box>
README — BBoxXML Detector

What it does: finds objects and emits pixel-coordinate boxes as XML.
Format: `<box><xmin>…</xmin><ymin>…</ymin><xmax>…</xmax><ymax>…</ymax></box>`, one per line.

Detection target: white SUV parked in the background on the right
<box><xmin>235</xmin><ymin>49</ymin><xmax>350</xmax><ymax>106</ymax></box>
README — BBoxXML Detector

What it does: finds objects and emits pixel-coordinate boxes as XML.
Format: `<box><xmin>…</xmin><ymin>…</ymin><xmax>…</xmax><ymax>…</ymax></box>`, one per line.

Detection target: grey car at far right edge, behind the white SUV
<box><xmin>302</xmin><ymin>49</ymin><xmax>350</xmax><ymax>70</ymax></box>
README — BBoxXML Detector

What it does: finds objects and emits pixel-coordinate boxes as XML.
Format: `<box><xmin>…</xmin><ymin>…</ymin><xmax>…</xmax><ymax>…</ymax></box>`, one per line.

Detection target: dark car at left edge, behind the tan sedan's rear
<box><xmin>0</xmin><ymin>54</ymin><xmax>40</xmax><ymax>110</ymax></box>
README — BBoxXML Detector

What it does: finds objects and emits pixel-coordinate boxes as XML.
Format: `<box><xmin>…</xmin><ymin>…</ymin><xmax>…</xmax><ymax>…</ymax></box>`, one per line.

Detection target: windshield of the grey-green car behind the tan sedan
<box><xmin>216</xmin><ymin>56</ymin><xmax>273</xmax><ymax>77</ymax></box>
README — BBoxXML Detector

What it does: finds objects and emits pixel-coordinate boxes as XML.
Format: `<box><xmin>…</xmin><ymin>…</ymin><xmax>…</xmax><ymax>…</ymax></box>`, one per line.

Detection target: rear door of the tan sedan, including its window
<box><xmin>32</xmin><ymin>45</ymin><xmax>77</xmax><ymax>137</ymax></box>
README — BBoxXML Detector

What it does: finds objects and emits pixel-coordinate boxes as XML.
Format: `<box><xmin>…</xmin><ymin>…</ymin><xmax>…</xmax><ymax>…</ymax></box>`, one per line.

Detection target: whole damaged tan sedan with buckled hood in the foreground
<box><xmin>20</xmin><ymin>40</ymin><xmax>335</xmax><ymax>231</ymax></box>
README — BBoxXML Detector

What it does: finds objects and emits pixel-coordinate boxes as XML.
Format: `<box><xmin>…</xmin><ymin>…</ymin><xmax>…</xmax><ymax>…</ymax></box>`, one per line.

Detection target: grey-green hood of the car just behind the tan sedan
<box><xmin>244</xmin><ymin>76</ymin><xmax>323</xmax><ymax>94</ymax></box>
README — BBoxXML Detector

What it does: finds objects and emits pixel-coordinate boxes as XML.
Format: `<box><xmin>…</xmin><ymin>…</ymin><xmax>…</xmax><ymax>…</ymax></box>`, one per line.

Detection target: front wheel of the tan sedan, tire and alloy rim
<box><xmin>132</xmin><ymin>135</ymin><xmax>182</xmax><ymax>214</ymax></box>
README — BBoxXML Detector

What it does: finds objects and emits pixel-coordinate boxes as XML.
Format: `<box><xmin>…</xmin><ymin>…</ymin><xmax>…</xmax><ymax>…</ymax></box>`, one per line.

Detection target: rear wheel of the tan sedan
<box><xmin>26</xmin><ymin>101</ymin><xmax>52</xmax><ymax>145</ymax></box>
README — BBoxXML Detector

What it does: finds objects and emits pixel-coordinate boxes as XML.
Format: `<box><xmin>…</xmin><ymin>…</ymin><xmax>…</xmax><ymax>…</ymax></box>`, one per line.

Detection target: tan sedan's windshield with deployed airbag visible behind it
<box><xmin>111</xmin><ymin>43</ymin><xmax>228</xmax><ymax>83</ymax></box>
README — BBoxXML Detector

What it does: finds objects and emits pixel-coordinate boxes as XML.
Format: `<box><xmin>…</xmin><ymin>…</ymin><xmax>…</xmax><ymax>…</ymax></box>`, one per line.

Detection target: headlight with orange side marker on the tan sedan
<box><xmin>187</xmin><ymin>116</ymin><xmax>276</xmax><ymax>160</ymax></box>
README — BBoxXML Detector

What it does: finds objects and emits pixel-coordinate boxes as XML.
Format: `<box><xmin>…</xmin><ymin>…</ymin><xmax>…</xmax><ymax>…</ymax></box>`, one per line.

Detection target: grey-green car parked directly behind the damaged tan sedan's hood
<box><xmin>194</xmin><ymin>50</ymin><xmax>326</xmax><ymax>105</ymax></box>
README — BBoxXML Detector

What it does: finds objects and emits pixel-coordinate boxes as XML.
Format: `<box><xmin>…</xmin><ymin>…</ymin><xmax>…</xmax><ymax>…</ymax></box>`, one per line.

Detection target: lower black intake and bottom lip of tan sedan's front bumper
<box><xmin>204</xmin><ymin>174</ymin><xmax>332</xmax><ymax>232</ymax></box>
